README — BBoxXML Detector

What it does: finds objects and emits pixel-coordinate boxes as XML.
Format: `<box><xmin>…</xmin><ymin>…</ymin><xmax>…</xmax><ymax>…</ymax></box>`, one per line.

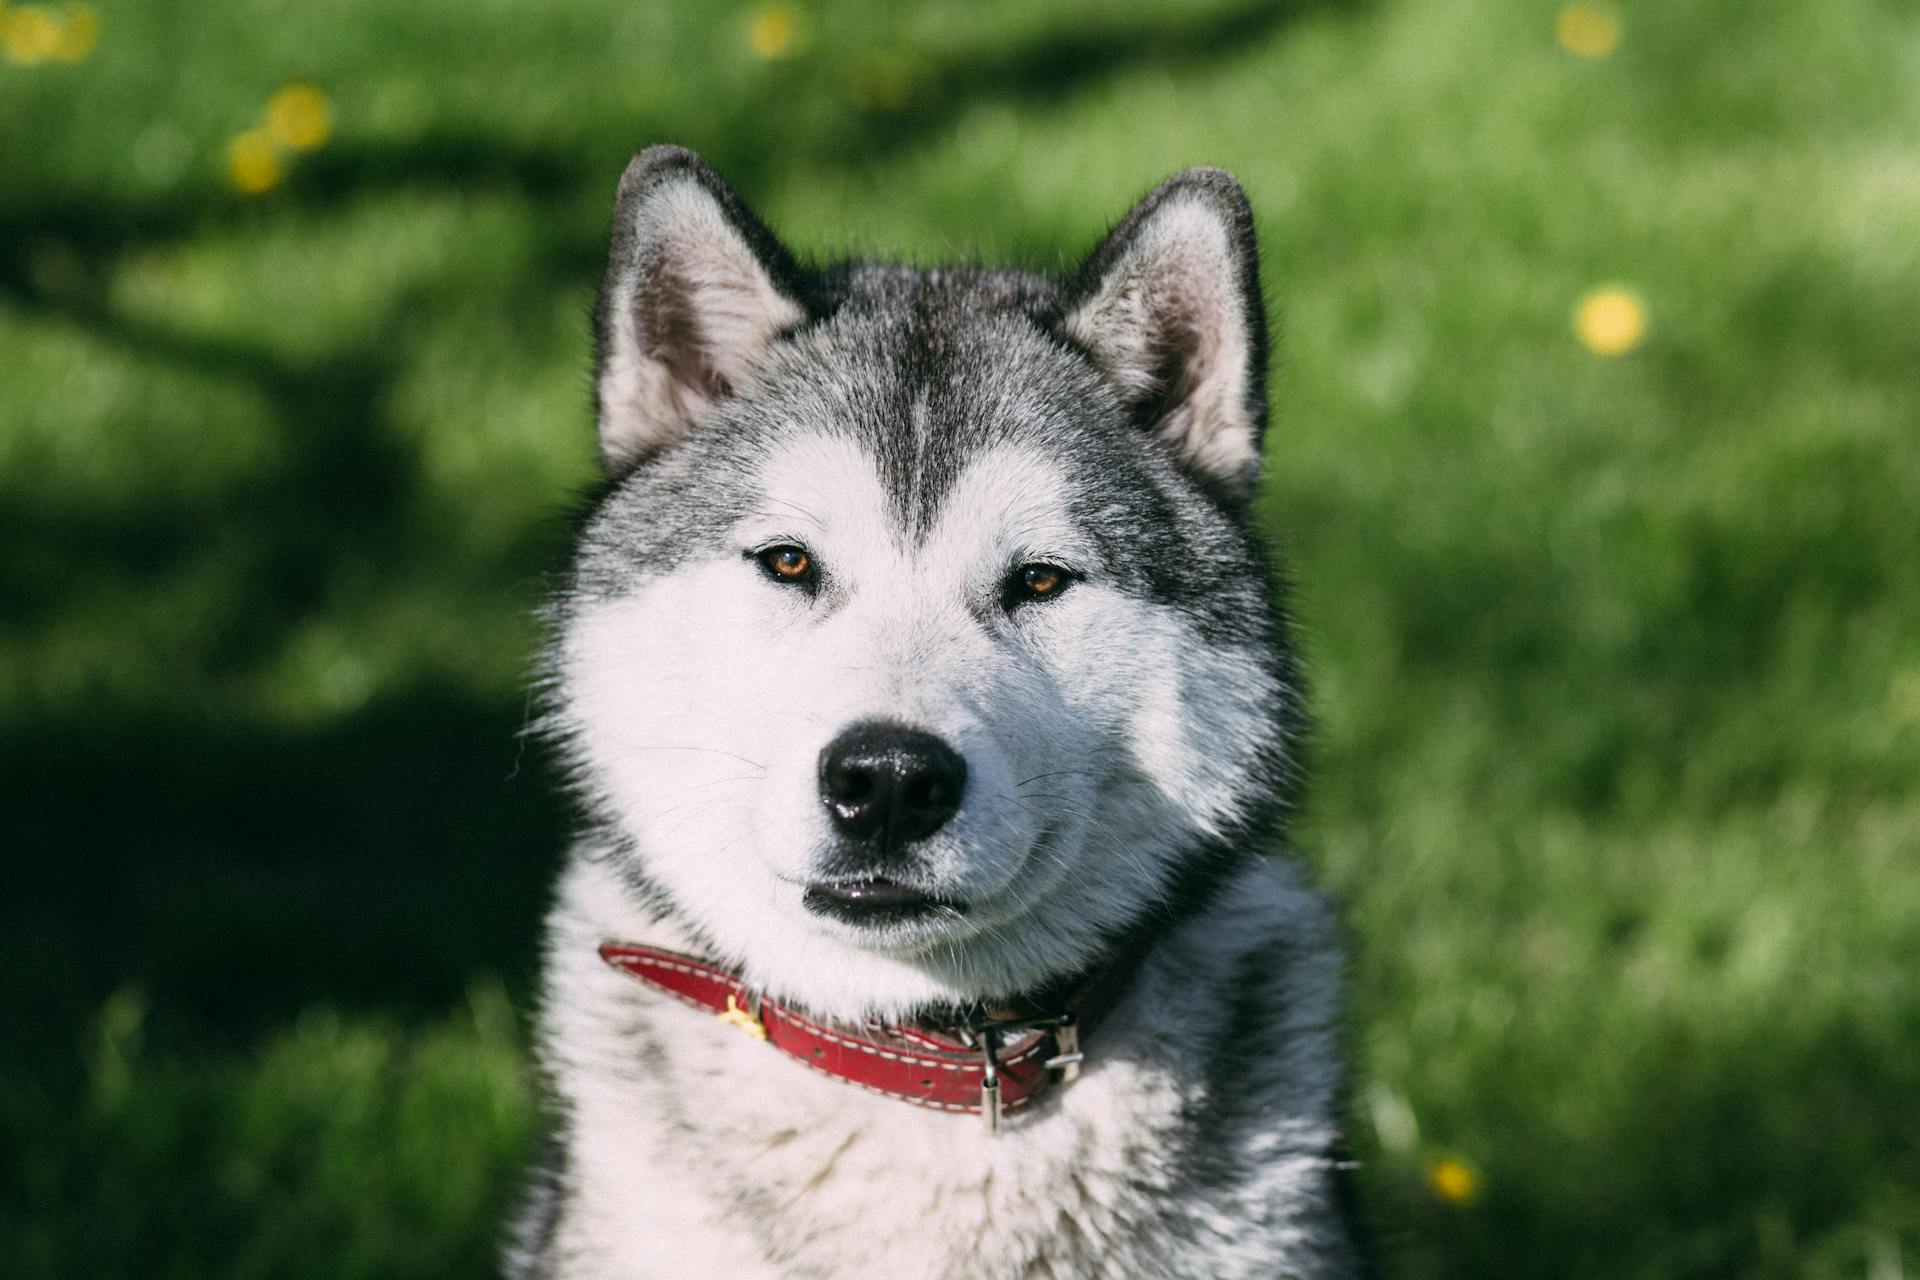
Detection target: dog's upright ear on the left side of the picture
<box><xmin>593</xmin><ymin>146</ymin><xmax>806</xmax><ymax>470</ymax></box>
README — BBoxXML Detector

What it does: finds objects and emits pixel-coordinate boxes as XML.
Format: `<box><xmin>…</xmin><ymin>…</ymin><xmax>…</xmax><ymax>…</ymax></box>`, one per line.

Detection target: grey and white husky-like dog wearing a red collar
<box><xmin>509</xmin><ymin>146</ymin><xmax>1365</xmax><ymax>1280</ymax></box>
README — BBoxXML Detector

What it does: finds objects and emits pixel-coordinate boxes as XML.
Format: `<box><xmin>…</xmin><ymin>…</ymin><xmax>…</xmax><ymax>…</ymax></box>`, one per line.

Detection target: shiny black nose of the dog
<box><xmin>820</xmin><ymin>723</ymin><xmax>966</xmax><ymax>850</ymax></box>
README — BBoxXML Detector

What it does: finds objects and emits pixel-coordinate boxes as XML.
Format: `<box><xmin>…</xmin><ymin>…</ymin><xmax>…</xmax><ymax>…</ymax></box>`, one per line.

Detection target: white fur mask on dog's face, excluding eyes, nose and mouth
<box><xmin>561</xmin><ymin>436</ymin><xmax>1275</xmax><ymax>1017</ymax></box>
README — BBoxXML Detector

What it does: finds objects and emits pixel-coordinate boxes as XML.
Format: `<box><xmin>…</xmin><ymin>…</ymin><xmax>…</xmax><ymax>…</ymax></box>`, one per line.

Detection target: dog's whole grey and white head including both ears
<box><xmin>555</xmin><ymin>150</ymin><xmax>1286</xmax><ymax>1015</ymax></box>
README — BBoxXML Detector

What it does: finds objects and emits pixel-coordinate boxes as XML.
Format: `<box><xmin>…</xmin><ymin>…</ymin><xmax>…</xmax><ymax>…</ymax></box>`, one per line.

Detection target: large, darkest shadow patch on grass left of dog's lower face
<box><xmin>0</xmin><ymin>685</ymin><xmax>563</xmax><ymax>1040</ymax></box>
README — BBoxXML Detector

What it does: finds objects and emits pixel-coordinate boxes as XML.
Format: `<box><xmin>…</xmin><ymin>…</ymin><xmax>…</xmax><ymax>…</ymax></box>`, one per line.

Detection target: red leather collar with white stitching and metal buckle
<box><xmin>599</xmin><ymin>942</ymin><xmax>1137</xmax><ymax>1132</ymax></box>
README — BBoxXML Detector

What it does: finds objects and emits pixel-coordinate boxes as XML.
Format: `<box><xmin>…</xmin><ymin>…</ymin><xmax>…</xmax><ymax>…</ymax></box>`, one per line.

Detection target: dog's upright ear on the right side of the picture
<box><xmin>1064</xmin><ymin>169</ymin><xmax>1267</xmax><ymax>497</ymax></box>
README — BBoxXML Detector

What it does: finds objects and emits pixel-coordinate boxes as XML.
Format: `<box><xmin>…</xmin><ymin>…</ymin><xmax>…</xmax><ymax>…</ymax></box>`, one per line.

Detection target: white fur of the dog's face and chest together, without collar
<box><xmin>541</xmin><ymin>436</ymin><xmax>1346</xmax><ymax>1280</ymax></box>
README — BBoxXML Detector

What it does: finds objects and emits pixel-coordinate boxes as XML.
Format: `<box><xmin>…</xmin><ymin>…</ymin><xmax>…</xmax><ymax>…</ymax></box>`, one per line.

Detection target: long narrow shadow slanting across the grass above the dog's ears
<box><xmin>0</xmin><ymin>0</ymin><xmax>1359</xmax><ymax>303</ymax></box>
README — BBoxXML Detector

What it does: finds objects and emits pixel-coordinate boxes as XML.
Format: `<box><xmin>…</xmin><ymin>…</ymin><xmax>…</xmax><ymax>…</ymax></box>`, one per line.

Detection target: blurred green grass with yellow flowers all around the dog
<box><xmin>0</xmin><ymin>0</ymin><xmax>1920</xmax><ymax>1280</ymax></box>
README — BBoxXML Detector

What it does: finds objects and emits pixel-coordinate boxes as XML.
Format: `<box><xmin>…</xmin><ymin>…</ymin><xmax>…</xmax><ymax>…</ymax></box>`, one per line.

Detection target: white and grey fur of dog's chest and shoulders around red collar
<box><xmin>529</xmin><ymin>856</ymin><xmax>1348</xmax><ymax>1278</ymax></box>
